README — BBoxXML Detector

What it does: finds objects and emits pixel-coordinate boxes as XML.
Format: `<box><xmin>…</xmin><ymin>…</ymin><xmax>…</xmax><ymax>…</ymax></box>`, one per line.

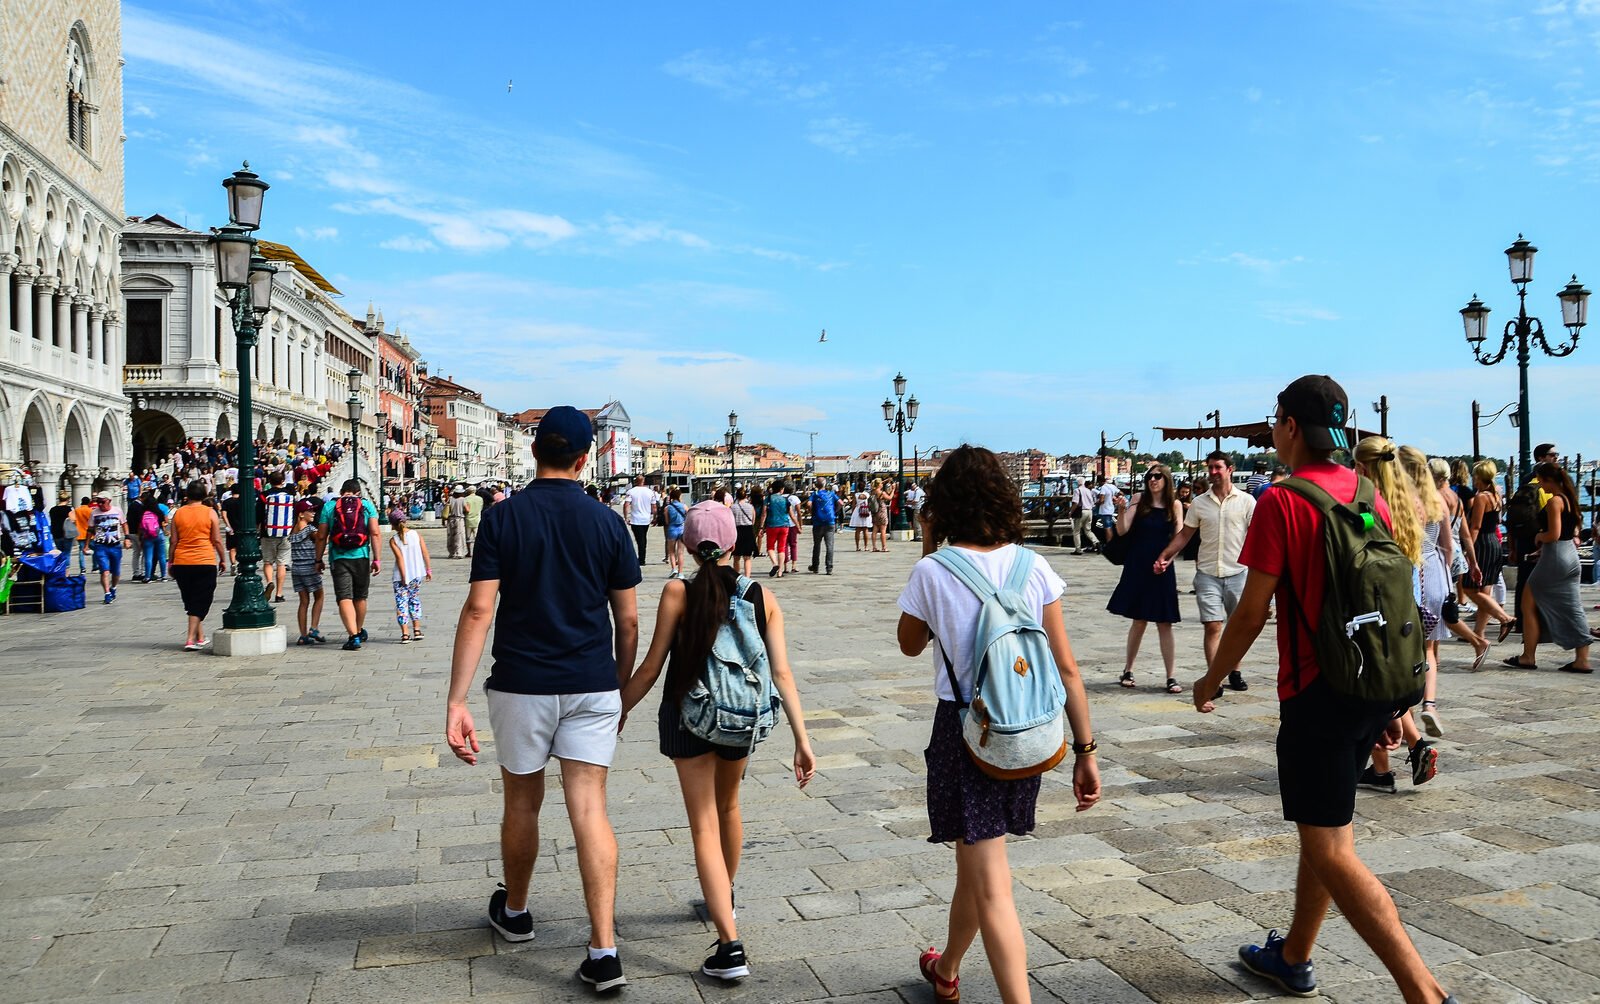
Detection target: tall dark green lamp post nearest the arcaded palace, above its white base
<box><xmin>211</xmin><ymin>161</ymin><xmax>277</xmax><ymax>628</ymax></box>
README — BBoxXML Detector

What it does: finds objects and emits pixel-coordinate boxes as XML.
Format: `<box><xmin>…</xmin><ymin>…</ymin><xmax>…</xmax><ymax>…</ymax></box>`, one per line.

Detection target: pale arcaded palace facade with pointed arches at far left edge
<box><xmin>0</xmin><ymin>0</ymin><xmax>130</xmax><ymax>496</ymax></box>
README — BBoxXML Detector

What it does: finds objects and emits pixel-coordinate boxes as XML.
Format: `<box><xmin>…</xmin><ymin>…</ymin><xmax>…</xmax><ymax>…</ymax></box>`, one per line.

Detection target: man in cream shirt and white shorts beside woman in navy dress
<box><xmin>1155</xmin><ymin>451</ymin><xmax>1256</xmax><ymax>697</ymax></box>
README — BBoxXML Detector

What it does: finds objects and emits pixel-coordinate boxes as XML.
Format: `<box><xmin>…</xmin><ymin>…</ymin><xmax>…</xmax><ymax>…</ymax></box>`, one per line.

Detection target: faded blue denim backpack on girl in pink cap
<box><xmin>680</xmin><ymin>568</ymin><xmax>782</xmax><ymax>753</ymax></box>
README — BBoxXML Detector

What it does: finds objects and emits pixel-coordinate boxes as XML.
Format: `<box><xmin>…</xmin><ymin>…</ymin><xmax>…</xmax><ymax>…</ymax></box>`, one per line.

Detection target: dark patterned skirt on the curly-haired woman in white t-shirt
<box><xmin>923</xmin><ymin>700</ymin><xmax>1038</xmax><ymax>844</ymax></box>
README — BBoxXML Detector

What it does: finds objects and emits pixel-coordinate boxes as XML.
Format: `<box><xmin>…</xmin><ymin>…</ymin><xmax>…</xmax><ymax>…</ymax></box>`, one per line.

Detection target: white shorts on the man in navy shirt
<box><xmin>485</xmin><ymin>691</ymin><xmax>622</xmax><ymax>774</ymax></box>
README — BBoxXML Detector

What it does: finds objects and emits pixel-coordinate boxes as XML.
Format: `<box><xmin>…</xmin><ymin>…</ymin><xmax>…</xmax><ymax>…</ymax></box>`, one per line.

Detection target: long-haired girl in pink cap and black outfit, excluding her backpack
<box><xmin>622</xmin><ymin>502</ymin><xmax>816</xmax><ymax>980</ymax></box>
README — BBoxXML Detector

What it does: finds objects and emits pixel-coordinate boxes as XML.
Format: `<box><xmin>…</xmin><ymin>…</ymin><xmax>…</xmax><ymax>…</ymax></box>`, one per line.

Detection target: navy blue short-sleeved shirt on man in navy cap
<box><xmin>472</xmin><ymin>478</ymin><xmax>640</xmax><ymax>694</ymax></box>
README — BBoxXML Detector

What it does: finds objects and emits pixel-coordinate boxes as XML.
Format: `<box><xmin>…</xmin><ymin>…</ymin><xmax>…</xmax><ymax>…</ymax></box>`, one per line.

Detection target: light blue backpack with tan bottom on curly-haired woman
<box><xmin>933</xmin><ymin>547</ymin><xmax>1067</xmax><ymax>780</ymax></box>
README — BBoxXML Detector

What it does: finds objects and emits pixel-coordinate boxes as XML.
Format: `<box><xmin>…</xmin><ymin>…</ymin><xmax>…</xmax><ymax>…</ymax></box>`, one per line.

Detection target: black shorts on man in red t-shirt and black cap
<box><xmin>1278</xmin><ymin>678</ymin><xmax>1394</xmax><ymax>827</ymax></box>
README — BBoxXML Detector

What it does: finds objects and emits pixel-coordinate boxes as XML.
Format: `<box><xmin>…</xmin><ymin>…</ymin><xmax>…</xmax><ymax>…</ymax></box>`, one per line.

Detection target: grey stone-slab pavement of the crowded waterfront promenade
<box><xmin>0</xmin><ymin>531</ymin><xmax>1600</xmax><ymax>1004</ymax></box>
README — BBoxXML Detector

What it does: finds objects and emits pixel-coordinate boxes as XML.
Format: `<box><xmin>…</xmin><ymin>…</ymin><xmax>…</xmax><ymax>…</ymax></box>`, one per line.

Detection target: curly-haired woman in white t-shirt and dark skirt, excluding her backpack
<box><xmin>896</xmin><ymin>446</ymin><xmax>1101</xmax><ymax>1004</ymax></box>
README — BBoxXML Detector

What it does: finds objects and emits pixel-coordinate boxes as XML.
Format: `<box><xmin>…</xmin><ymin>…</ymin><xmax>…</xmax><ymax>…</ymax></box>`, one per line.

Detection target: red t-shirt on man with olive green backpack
<box><xmin>1238</xmin><ymin>462</ymin><xmax>1390</xmax><ymax>700</ymax></box>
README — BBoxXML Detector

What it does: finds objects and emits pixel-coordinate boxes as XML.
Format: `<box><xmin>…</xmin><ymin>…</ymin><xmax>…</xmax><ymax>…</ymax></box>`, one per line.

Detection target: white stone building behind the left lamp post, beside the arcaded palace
<box><xmin>122</xmin><ymin>216</ymin><xmax>347</xmax><ymax>468</ymax></box>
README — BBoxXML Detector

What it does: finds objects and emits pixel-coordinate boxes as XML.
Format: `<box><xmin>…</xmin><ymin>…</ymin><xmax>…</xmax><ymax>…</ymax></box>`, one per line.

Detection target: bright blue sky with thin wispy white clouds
<box><xmin>123</xmin><ymin>0</ymin><xmax>1600</xmax><ymax>456</ymax></box>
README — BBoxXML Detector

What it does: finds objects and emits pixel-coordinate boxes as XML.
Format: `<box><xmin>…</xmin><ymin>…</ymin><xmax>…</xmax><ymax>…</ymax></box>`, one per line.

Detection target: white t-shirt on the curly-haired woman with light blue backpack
<box><xmin>899</xmin><ymin>544</ymin><xmax>1067</xmax><ymax>700</ymax></box>
